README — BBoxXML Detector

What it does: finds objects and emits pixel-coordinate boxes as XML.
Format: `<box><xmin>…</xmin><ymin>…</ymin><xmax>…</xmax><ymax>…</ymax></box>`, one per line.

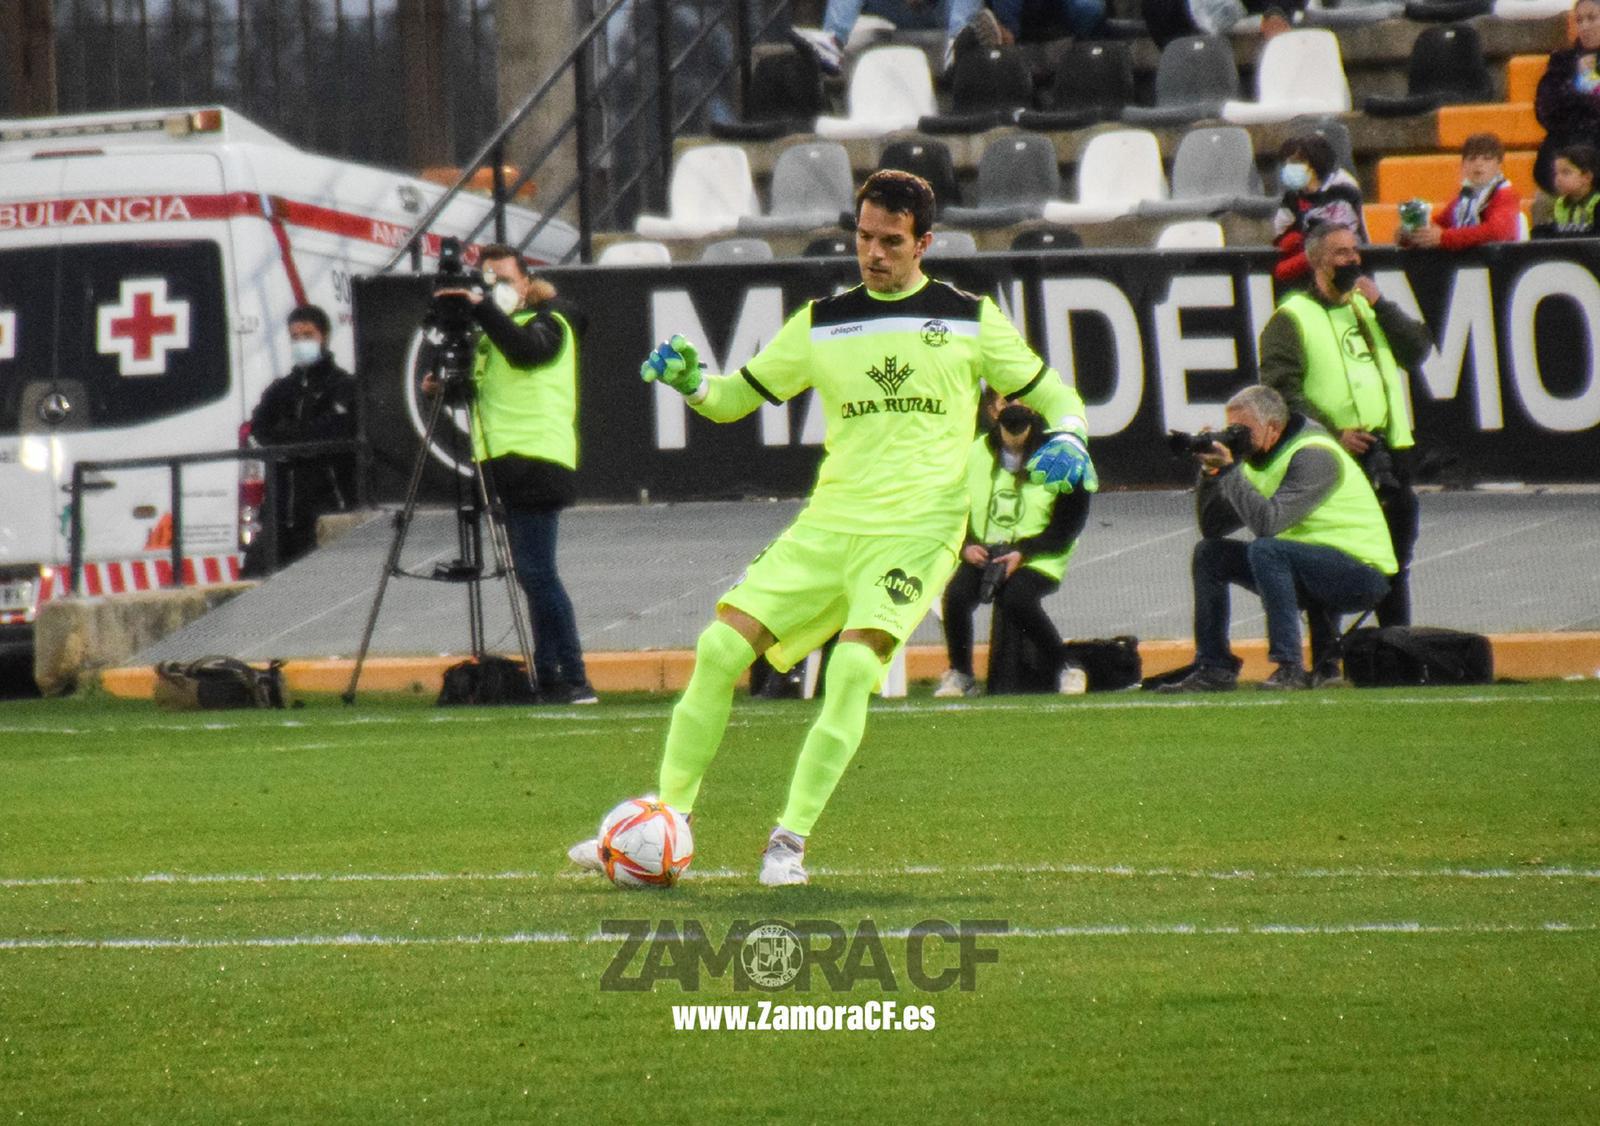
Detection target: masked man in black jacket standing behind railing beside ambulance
<box><xmin>245</xmin><ymin>305</ymin><xmax>357</xmax><ymax>574</ymax></box>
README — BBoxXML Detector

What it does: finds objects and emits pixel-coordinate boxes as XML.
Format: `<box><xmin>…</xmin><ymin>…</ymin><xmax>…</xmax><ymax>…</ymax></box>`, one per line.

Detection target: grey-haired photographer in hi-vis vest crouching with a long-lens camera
<box><xmin>1162</xmin><ymin>384</ymin><xmax>1395</xmax><ymax>693</ymax></box>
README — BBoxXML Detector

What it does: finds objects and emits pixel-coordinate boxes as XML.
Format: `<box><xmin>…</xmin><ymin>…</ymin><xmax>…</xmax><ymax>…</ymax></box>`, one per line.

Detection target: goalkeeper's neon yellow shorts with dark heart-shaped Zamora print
<box><xmin>718</xmin><ymin>525</ymin><xmax>955</xmax><ymax>672</ymax></box>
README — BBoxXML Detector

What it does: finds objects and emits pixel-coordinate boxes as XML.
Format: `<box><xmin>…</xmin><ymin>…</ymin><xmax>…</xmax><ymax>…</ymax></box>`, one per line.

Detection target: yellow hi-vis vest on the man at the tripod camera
<box><xmin>472</xmin><ymin>309</ymin><xmax>578</xmax><ymax>469</ymax></box>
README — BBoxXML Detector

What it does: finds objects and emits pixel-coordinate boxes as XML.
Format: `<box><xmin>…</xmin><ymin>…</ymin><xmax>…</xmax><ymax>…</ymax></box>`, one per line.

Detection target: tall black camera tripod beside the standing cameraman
<box><xmin>341</xmin><ymin>365</ymin><xmax>538</xmax><ymax>704</ymax></box>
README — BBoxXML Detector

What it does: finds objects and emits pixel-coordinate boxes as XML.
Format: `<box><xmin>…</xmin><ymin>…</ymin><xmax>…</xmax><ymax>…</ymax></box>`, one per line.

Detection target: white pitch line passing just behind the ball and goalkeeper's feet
<box><xmin>0</xmin><ymin>864</ymin><xmax>1600</xmax><ymax>888</ymax></box>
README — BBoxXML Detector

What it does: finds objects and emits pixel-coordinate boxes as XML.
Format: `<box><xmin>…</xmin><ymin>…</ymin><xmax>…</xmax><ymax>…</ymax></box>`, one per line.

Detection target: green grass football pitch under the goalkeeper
<box><xmin>0</xmin><ymin>683</ymin><xmax>1600</xmax><ymax>1123</ymax></box>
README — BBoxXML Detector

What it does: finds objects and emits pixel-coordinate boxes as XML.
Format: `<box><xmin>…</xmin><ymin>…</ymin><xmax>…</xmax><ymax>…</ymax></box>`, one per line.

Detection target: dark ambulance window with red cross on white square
<box><xmin>0</xmin><ymin>242</ymin><xmax>229</xmax><ymax>433</ymax></box>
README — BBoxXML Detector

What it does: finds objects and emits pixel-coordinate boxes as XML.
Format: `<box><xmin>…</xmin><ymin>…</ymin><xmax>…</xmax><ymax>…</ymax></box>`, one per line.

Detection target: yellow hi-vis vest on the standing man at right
<box><xmin>1278</xmin><ymin>293</ymin><xmax>1414</xmax><ymax>449</ymax></box>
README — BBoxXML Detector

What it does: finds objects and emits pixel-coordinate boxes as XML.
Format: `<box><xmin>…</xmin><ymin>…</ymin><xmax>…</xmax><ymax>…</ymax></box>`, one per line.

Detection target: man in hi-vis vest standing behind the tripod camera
<box><xmin>424</xmin><ymin>245</ymin><xmax>597</xmax><ymax>704</ymax></box>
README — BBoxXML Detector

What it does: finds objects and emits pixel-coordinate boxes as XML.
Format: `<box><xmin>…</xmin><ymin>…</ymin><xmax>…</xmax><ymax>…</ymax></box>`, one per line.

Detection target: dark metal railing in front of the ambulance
<box><xmin>67</xmin><ymin>438</ymin><xmax>366</xmax><ymax>595</ymax></box>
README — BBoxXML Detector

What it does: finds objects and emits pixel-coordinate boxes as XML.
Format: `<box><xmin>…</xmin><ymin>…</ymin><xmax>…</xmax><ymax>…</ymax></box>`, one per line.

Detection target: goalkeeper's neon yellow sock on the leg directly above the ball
<box><xmin>659</xmin><ymin>621</ymin><xmax>755</xmax><ymax>814</ymax></box>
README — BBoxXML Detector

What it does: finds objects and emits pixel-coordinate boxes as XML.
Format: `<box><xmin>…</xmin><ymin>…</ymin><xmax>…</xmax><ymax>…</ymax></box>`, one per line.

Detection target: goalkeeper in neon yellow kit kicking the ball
<box><xmin>568</xmin><ymin>171</ymin><xmax>1098</xmax><ymax>886</ymax></box>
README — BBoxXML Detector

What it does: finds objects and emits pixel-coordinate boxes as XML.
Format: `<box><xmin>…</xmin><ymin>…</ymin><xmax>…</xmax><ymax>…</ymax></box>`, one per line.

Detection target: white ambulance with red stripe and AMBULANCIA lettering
<box><xmin>0</xmin><ymin>107</ymin><xmax>578</xmax><ymax>654</ymax></box>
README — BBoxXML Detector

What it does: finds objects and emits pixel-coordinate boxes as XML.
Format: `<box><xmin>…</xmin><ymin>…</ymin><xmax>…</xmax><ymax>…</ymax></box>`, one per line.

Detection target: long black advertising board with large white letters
<box><xmin>355</xmin><ymin>240</ymin><xmax>1600</xmax><ymax>501</ymax></box>
